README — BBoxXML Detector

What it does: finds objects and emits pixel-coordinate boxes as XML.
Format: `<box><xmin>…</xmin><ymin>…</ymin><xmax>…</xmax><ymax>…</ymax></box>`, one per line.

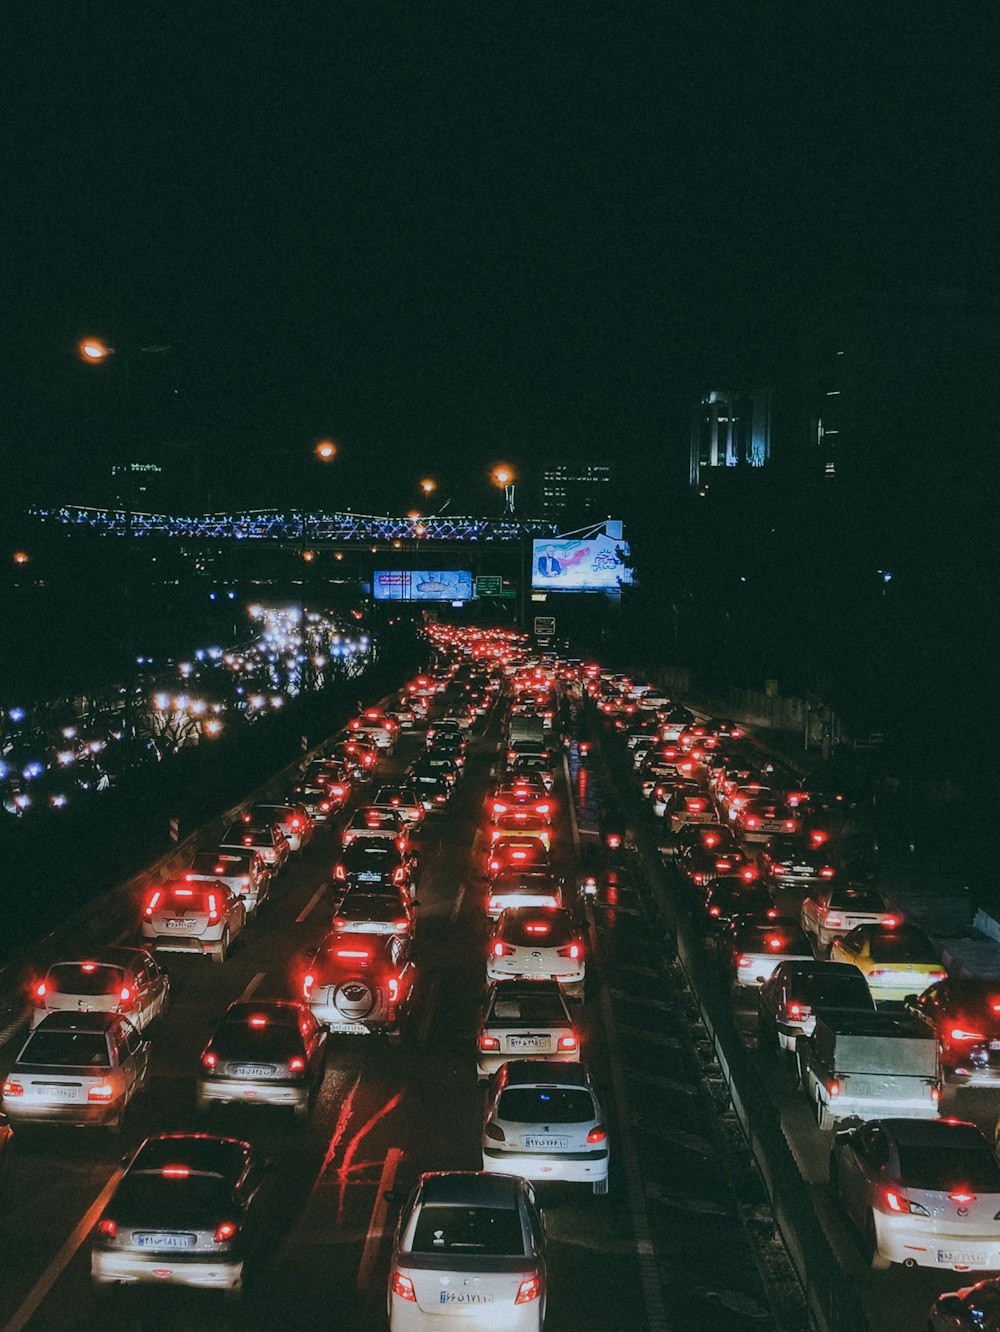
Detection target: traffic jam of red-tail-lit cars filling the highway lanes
<box><xmin>0</xmin><ymin>623</ymin><xmax>1000</xmax><ymax>1332</ymax></box>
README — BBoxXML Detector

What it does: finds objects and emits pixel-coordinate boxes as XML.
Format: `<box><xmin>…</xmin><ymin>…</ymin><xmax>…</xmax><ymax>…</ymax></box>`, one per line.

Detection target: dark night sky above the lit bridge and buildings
<box><xmin>0</xmin><ymin>0</ymin><xmax>1000</xmax><ymax>511</ymax></box>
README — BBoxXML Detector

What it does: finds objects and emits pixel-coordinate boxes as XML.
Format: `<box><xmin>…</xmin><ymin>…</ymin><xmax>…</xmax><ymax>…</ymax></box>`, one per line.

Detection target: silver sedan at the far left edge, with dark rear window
<box><xmin>3</xmin><ymin>1012</ymin><xmax>149</xmax><ymax>1132</ymax></box>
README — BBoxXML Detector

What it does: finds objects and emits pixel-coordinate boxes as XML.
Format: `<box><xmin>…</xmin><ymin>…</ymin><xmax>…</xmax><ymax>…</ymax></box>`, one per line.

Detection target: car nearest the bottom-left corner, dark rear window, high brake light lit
<box><xmin>91</xmin><ymin>1134</ymin><xmax>269</xmax><ymax>1295</ymax></box>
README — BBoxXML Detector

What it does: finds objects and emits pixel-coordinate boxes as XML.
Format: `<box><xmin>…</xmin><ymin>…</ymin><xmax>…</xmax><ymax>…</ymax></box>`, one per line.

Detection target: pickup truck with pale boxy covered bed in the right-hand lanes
<box><xmin>795</xmin><ymin>1008</ymin><xmax>941</xmax><ymax>1128</ymax></box>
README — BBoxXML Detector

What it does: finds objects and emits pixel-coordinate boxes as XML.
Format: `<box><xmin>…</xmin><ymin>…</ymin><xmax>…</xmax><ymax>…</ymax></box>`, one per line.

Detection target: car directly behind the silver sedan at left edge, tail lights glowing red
<box><xmin>31</xmin><ymin>948</ymin><xmax>170</xmax><ymax>1031</ymax></box>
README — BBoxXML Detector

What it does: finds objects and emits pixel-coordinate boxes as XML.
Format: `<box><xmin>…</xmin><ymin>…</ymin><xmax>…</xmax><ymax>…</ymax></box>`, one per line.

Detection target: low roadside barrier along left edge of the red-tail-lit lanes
<box><xmin>0</xmin><ymin>695</ymin><xmax>391</xmax><ymax>1047</ymax></box>
